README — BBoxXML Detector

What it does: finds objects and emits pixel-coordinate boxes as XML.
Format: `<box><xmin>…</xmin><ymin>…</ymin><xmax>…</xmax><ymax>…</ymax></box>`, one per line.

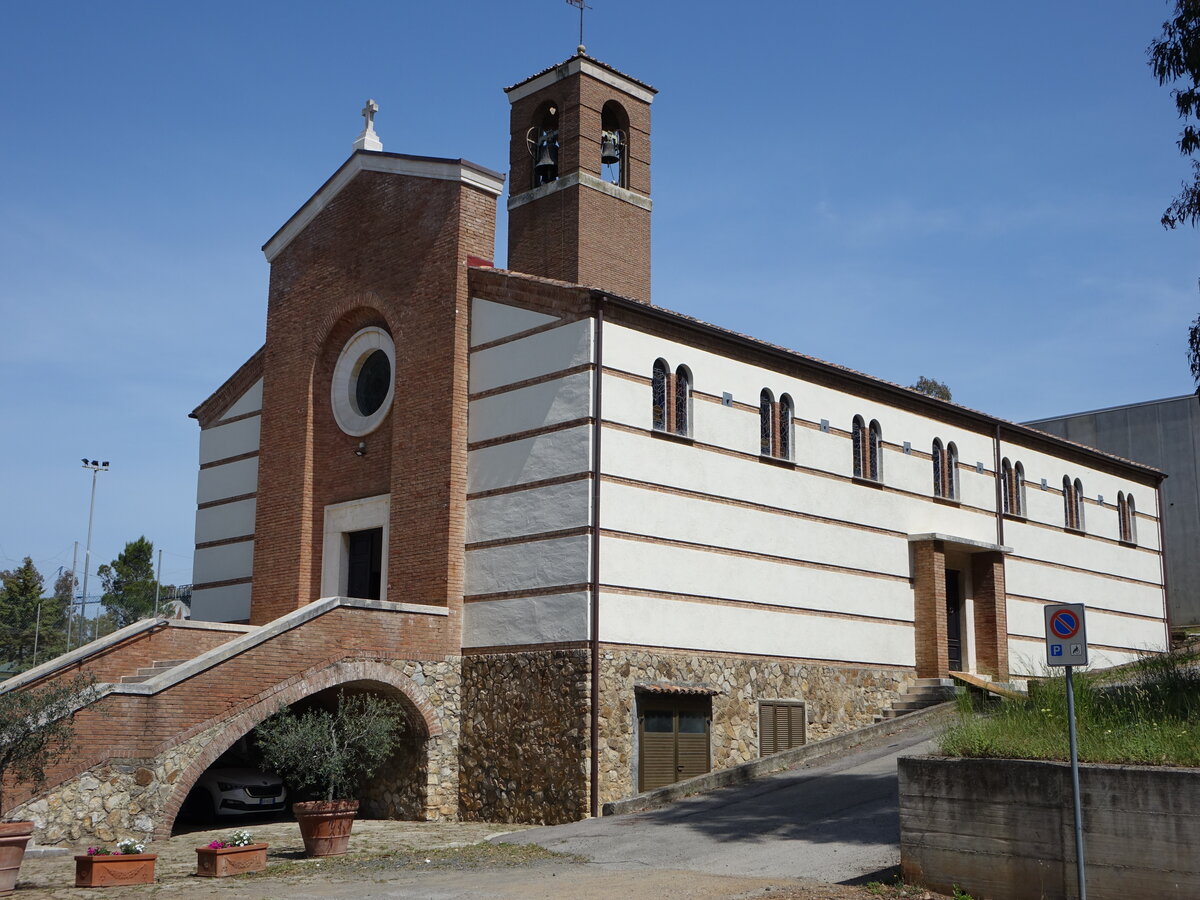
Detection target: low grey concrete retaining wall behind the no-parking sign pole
<box><xmin>900</xmin><ymin>757</ymin><xmax>1200</xmax><ymax>900</ymax></box>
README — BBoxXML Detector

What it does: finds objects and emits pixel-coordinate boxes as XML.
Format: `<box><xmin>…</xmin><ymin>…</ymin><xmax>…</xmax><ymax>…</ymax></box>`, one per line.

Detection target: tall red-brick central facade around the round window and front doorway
<box><xmin>251</xmin><ymin>164</ymin><xmax>496</xmax><ymax>628</ymax></box>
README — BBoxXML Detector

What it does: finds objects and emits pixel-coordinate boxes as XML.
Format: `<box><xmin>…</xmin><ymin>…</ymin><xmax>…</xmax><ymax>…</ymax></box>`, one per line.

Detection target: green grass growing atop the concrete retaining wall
<box><xmin>941</xmin><ymin>649</ymin><xmax>1200</xmax><ymax>766</ymax></box>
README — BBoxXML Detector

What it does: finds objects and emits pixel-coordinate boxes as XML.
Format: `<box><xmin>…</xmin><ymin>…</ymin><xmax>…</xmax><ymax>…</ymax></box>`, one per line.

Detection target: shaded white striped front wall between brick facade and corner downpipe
<box><xmin>463</xmin><ymin>299</ymin><xmax>593</xmax><ymax>648</ymax></box>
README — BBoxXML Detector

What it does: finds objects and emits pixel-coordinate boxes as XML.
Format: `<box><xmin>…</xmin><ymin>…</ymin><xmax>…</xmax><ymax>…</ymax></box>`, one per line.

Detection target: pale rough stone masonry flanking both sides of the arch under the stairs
<box><xmin>15</xmin><ymin>656</ymin><xmax>462</xmax><ymax>846</ymax></box>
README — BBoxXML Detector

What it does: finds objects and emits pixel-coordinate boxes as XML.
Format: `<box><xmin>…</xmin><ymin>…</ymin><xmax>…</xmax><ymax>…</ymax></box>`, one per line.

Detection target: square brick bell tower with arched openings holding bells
<box><xmin>505</xmin><ymin>55</ymin><xmax>656</xmax><ymax>302</ymax></box>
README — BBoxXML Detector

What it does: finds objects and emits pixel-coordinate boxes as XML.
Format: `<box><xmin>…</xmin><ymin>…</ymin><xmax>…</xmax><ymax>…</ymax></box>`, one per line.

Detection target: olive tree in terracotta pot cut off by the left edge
<box><xmin>0</xmin><ymin>674</ymin><xmax>95</xmax><ymax>894</ymax></box>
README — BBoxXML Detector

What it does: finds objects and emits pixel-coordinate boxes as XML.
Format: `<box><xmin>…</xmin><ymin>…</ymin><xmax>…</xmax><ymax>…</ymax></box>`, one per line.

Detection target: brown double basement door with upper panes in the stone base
<box><xmin>637</xmin><ymin>694</ymin><xmax>713</xmax><ymax>791</ymax></box>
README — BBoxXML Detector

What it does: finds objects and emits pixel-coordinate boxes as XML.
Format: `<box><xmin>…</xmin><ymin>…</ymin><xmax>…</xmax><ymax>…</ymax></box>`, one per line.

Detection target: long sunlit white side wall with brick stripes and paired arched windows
<box><xmin>600</xmin><ymin>323</ymin><xmax>1165</xmax><ymax>661</ymax></box>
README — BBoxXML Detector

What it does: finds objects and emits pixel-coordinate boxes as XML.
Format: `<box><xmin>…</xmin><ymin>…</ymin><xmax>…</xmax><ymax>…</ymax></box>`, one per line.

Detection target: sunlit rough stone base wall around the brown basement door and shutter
<box><xmin>599</xmin><ymin>648</ymin><xmax>916</xmax><ymax>803</ymax></box>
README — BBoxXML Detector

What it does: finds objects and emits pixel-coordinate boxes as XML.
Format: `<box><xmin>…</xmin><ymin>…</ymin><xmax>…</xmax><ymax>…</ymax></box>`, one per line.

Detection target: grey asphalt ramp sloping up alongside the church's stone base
<box><xmin>496</xmin><ymin>730</ymin><xmax>934</xmax><ymax>883</ymax></box>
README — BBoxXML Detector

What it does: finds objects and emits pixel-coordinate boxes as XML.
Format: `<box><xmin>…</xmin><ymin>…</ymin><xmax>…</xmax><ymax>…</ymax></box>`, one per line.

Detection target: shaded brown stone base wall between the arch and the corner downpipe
<box><xmin>458</xmin><ymin>649</ymin><xmax>592</xmax><ymax>824</ymax></box>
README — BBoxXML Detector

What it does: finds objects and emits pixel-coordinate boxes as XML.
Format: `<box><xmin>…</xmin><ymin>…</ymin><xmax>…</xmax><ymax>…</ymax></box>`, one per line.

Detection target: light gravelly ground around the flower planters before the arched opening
<box><xmin>13</xmin><ymin>820</ymin><xmax>942</xmax><ymax>900</ymax></box>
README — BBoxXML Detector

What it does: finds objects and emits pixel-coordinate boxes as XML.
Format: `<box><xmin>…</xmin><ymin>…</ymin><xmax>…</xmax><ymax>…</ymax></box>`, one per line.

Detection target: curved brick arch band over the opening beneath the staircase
<box><xmin>154</xmin><ymin>660</ymin><xmax>442</xmax><ymax>840</ymax></box>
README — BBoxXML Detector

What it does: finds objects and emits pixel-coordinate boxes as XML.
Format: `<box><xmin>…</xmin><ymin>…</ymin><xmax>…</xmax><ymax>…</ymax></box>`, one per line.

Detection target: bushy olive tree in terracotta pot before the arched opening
<box><xmin>254</xmin><ymin>691</ymin><xmax>407</xmax><ymax>857</ymax></box>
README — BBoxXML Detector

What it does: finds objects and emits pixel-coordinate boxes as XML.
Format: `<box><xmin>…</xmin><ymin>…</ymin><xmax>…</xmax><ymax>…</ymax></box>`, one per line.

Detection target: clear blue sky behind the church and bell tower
<box><xmin>0</xmin><ymin>0</ymin><xmax>1200</xmax><ymax>587</ymax></box>
